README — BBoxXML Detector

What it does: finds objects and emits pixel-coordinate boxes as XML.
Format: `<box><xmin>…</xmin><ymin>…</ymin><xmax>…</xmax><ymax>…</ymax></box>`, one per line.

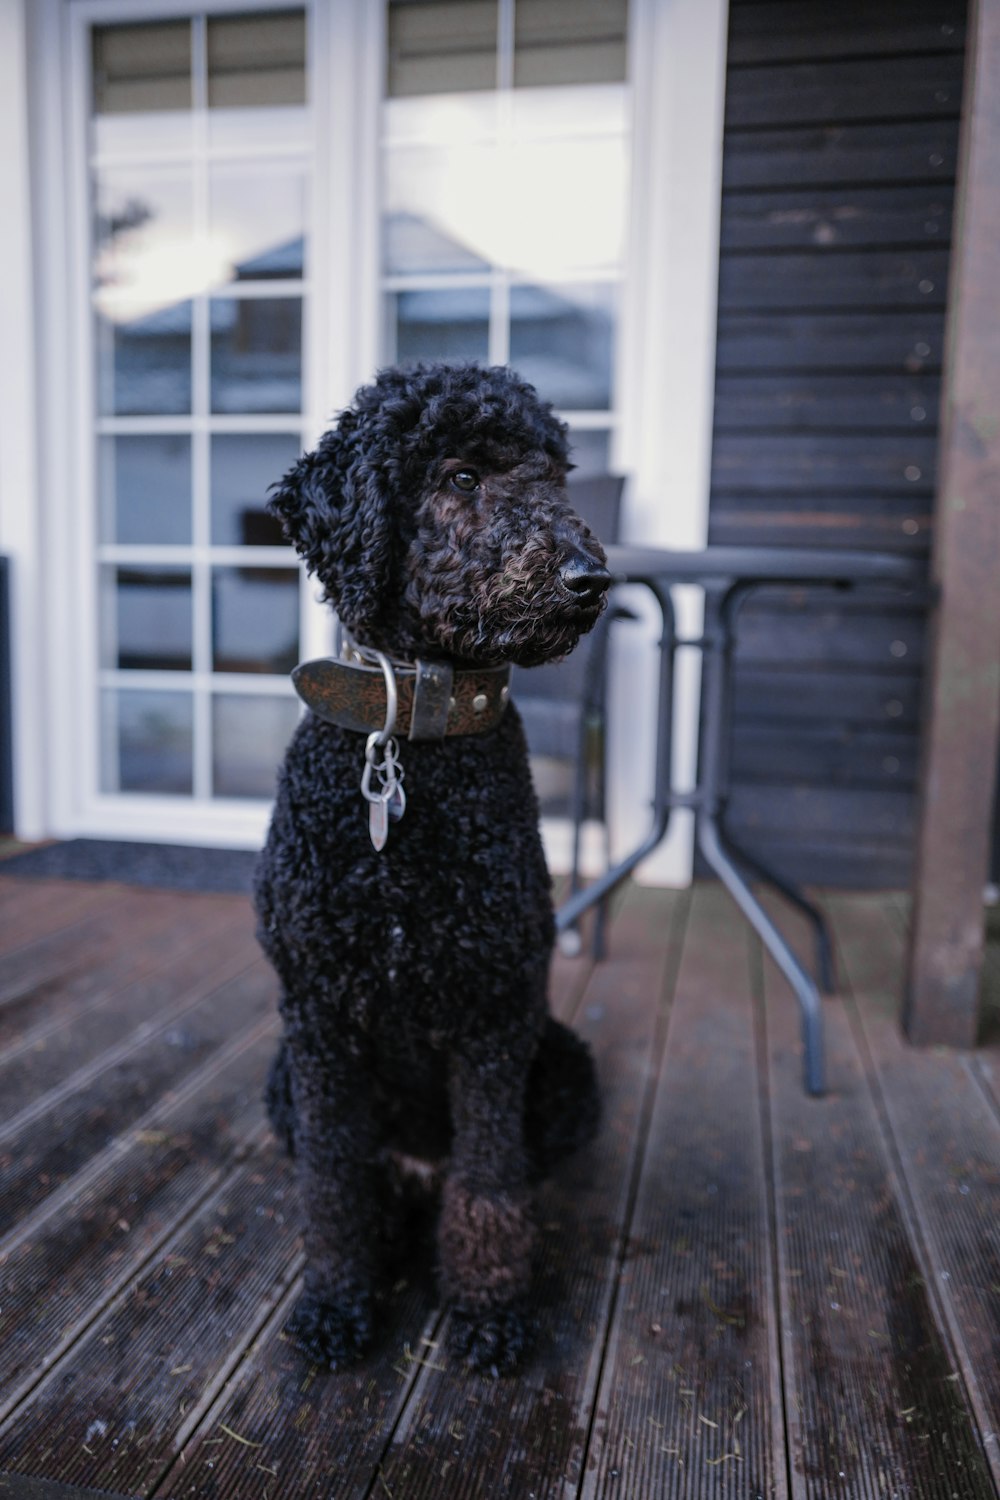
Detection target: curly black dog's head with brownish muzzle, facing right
<box><xmin>270</xmin><ymin>365</ymin><xmax>610</xmax><ymax>666</ymax></box>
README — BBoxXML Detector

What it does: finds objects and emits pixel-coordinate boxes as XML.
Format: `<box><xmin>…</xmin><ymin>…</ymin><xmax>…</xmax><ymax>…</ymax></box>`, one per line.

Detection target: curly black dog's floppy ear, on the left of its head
<box><xmin>267</xmin><ymin>413</ymin><xmax>391</xmax><ymax>642</ymax></box>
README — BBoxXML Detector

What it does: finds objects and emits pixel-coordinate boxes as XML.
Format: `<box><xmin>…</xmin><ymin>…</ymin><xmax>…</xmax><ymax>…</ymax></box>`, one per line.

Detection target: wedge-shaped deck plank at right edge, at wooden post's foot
<box><xmin>826</xmin><ymin>897</ymin><xmax>1000</xmax><ymax>1491</ymax></box>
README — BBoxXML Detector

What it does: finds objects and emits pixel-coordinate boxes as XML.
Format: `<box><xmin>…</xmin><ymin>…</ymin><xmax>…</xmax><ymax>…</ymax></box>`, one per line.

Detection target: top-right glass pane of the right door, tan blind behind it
<box><xmin>514</xmin><ymin>0</ymin><xmax>628</xmax><ymax>86</ymax></box>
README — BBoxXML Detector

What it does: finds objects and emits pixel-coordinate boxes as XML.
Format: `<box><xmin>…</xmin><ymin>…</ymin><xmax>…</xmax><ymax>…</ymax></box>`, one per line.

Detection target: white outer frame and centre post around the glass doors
<box><xmin>9</xmin><ymin>0</ymin><xmax>727</xmax><ymax>884</ymax></box>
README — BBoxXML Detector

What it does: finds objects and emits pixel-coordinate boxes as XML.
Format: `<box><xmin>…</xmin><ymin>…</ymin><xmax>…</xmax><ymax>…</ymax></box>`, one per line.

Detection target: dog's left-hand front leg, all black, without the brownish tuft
<box><xmin>286</xmin><ymin>1038</ymin><xmax>376</xmax><ymax>1370</ymax></box>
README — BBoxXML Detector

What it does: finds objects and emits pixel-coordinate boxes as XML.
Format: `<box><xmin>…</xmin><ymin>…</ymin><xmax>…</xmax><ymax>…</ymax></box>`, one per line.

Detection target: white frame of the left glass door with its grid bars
<box><xmin>20</xmin><ymin>0</ymin><xmax>381</xmax><ymax>848</ymax></box>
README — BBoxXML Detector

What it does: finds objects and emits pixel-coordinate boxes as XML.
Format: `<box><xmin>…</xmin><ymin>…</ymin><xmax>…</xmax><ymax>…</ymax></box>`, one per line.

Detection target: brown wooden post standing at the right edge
<box><xmin>904</xmin><ymin>0</ymin><xmax>1000</xmax><ymax>1047</ymax></box>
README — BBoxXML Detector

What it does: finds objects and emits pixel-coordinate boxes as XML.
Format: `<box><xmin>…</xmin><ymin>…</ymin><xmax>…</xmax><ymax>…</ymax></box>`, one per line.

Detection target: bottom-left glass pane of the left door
<box><xmin>100</xmin><ymin>689</ymin><xmax>195</xmax><ymax>797</ymax></box>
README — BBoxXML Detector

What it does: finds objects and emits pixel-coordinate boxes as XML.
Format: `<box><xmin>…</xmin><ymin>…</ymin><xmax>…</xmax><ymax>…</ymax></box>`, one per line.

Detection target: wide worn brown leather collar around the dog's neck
<box><xmin>292</xmin><ymin>654</ymin><xmax>510</xmax><ymax>740</ymax></box>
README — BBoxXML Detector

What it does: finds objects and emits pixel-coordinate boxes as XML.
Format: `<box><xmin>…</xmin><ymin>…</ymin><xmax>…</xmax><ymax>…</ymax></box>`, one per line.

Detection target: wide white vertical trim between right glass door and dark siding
<box><xmin>610</xmin><ymin>0</ymin><xmax>729</xmax><ymax>885</ymax></box>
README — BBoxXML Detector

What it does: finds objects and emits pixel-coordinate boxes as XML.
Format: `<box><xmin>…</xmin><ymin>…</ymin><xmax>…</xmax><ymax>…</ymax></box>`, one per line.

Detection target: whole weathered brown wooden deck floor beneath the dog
<box><xmin>0</xmin><ymin>876</ymin><xmax>1000</xmax><ymax>1500</ymax></box>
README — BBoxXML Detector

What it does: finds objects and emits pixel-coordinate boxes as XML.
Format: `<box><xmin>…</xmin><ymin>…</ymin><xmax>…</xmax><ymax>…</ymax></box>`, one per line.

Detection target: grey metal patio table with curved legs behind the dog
<box><xmin>556</xmin><ymin>546</ymin><xmax>930</xmax><ymax>1094</ymax></box>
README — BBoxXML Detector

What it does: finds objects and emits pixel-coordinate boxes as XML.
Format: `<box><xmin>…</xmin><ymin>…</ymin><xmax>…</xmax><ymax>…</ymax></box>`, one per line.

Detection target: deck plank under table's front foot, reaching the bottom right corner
<box><xmin>765</xmin><ymin>911</ymin><xmax>996</xmax><ymax>1500</ymax></box>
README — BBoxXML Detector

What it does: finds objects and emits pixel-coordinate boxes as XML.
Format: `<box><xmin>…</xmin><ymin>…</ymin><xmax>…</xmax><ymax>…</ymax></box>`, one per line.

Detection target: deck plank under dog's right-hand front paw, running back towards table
<box><xmin>364</xmin><ymin>888</ymin><xmax>687</xmax><ymax>1500</ymax></box>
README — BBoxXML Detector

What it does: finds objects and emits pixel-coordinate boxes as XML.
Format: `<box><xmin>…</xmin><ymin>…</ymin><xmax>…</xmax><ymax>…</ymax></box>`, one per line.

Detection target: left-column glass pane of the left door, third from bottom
<box><xmin>97</xmin><ymin>434</ymin><xmax>190</xmax><ymax>545</ymax></box>
